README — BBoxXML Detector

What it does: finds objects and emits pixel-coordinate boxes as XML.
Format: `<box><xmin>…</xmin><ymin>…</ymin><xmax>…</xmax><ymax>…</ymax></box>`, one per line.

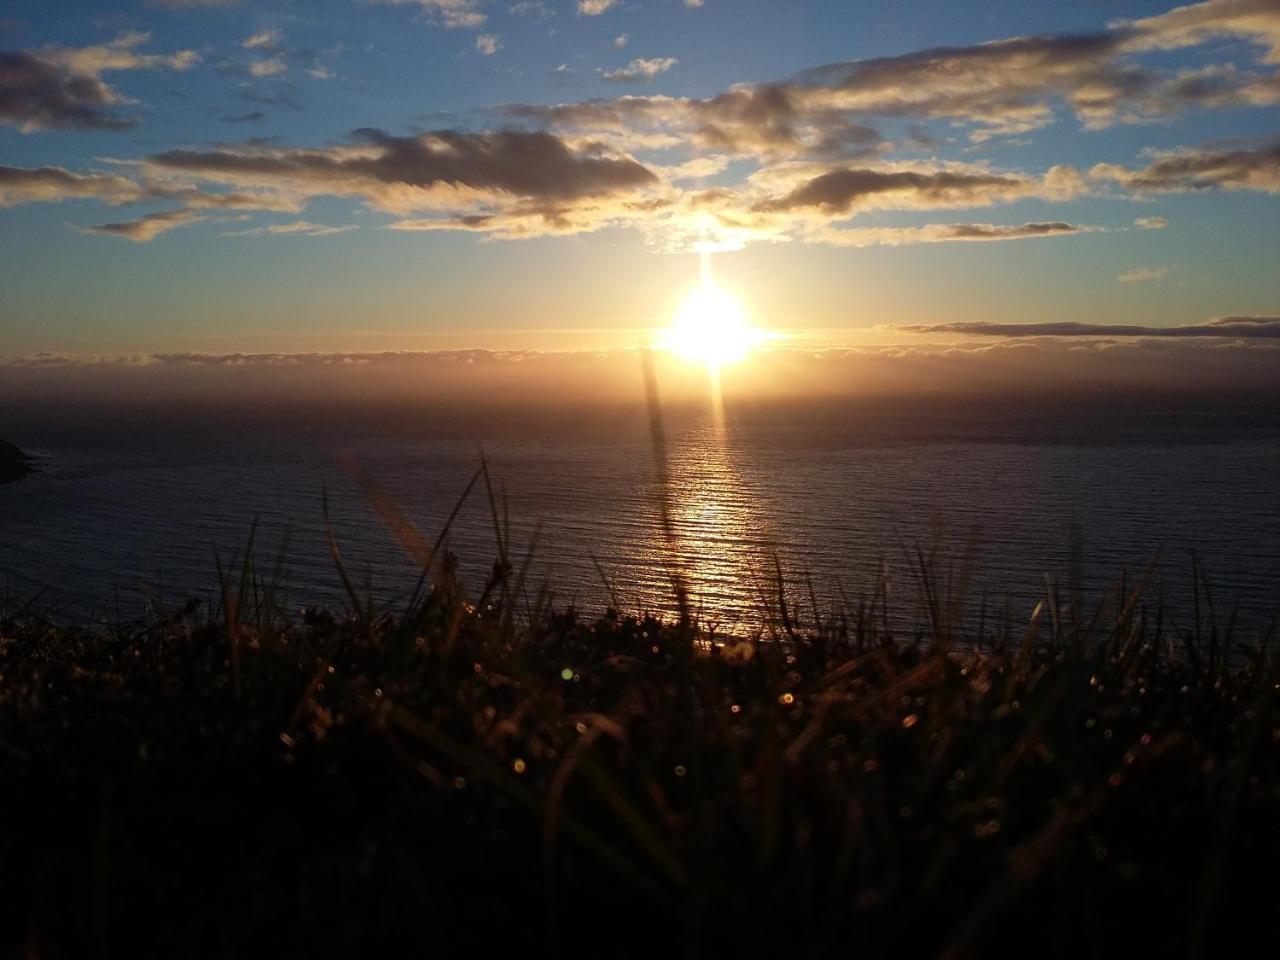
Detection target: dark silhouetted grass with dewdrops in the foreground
<box><xmin>0</xmin><ymin>517</ymin><xmax>1280</xmax><ymax>957</ymax></box>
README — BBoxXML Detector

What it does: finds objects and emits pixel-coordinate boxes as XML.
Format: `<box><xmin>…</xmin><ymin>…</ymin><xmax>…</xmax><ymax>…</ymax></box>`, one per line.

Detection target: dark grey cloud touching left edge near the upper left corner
<box><xmin>0</xmin><ymin>32</ymin><xmax>200</xmax><ymax>132</ymax></box>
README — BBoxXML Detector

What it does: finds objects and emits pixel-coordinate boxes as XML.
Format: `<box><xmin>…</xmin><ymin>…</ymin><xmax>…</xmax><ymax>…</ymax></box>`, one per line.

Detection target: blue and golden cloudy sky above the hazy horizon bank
<box><xmin>0</xmin><ymin>0</ymin><xmax>1280</xmax><ymax>358</ymax></box>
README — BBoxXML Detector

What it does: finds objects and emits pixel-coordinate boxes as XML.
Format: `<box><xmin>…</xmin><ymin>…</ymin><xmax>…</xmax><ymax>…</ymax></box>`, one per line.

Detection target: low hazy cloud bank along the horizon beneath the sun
<box><xmin>0</xmin><ymin>337</ymin><xmax>1280</xmax><ymax>414</ymax></box>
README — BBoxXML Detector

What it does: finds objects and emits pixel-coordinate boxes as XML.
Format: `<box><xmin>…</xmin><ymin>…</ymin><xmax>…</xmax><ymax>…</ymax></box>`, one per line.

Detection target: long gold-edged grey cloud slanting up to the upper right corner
<box><xmin>508</xmin><ymin>0</ymin><xmax>1280</xmax><ymax>156</ymax></box>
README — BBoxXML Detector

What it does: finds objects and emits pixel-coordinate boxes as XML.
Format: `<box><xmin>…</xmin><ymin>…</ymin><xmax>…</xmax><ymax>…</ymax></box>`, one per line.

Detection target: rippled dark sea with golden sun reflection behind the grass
<box><xmin>0</xmin><ymin>402</ymin><xmax>1280</xmax><ymax>640</ymax></box>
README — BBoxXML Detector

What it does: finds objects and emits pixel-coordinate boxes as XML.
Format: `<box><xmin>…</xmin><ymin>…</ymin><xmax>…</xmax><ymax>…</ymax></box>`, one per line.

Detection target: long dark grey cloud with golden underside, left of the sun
<box><xmin>0</xmin><ymin>131</ymin><xmax>663</xmax><ymax>242</ymax></box>
